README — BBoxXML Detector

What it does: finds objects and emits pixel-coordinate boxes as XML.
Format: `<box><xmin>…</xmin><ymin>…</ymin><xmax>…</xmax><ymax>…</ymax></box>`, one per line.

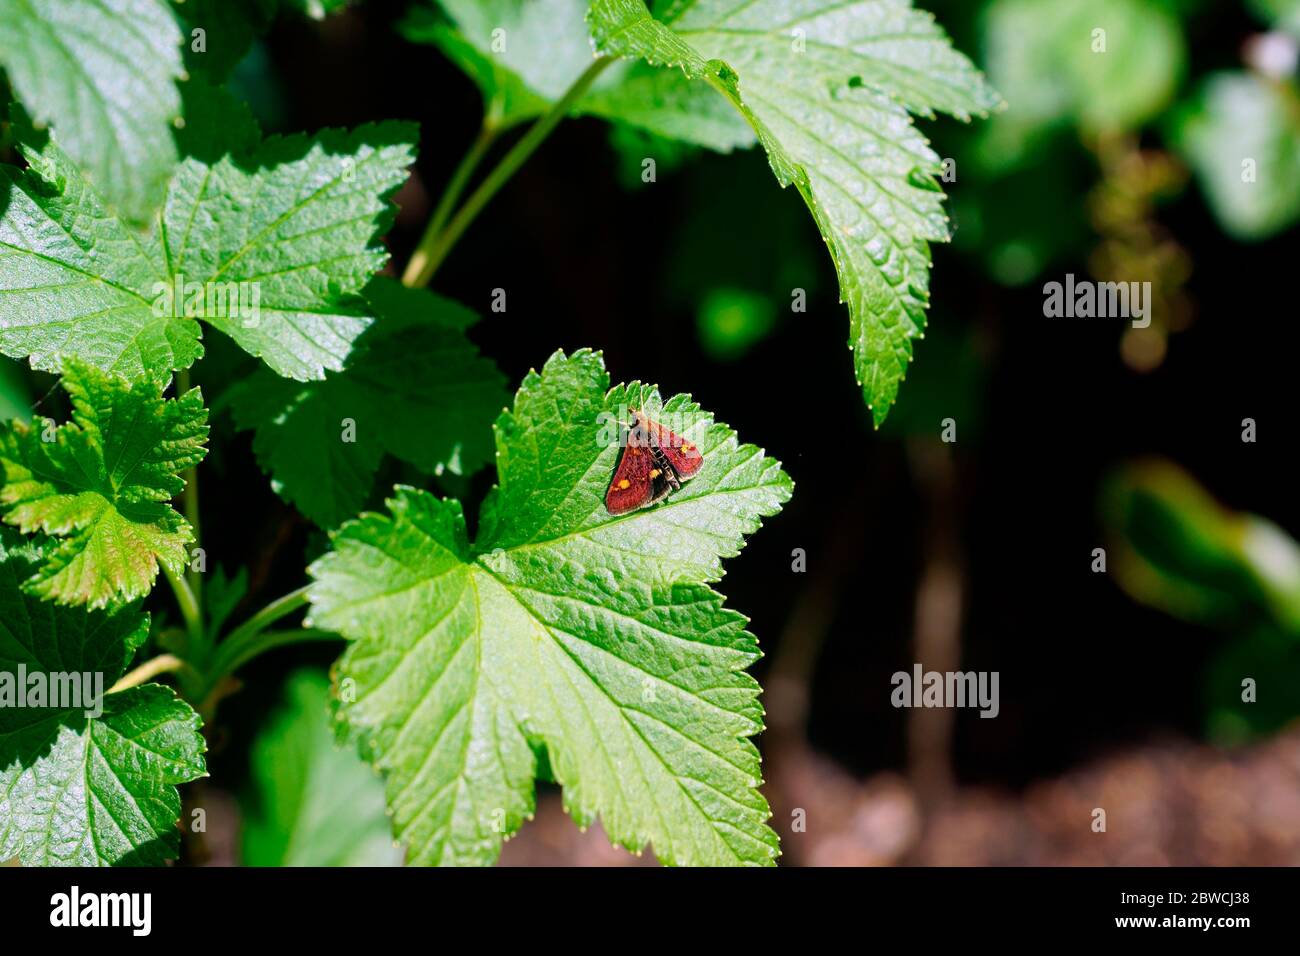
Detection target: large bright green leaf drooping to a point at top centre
<box><xmin>589</xmin><ymin>0</ymin><xmax>1000</xmax><ymax>425</ymax></box>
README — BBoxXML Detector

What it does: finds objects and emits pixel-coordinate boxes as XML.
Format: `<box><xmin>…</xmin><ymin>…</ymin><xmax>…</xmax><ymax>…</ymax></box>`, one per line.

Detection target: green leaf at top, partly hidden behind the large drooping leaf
<box><xmin>403</xmin><ymin>0</ymin><xmax>754</xmax><ymax>152</ymax></box>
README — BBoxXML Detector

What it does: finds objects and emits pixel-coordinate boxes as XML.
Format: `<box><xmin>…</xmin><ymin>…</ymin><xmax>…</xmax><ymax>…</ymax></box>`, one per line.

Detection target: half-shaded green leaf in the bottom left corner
<box><xmin>0</xmin><ymin>529</ymin><xmax>204</xmax><ymax>866</ymax></box>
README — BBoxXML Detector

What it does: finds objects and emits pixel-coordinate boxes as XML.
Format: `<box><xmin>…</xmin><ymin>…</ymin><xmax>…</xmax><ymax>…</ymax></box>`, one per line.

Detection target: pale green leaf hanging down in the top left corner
<box><xmin>0</xmin><ymin>0</ymin><xmax>182</xmax><ymax>222</ymax></box>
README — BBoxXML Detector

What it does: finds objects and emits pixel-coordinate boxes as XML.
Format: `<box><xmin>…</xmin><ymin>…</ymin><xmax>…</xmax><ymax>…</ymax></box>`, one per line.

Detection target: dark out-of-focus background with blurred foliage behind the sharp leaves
<box><xmin>5</xmin><ymin>0</ymin><xmax>1300</xmax><ymax>864</ymax></box>
